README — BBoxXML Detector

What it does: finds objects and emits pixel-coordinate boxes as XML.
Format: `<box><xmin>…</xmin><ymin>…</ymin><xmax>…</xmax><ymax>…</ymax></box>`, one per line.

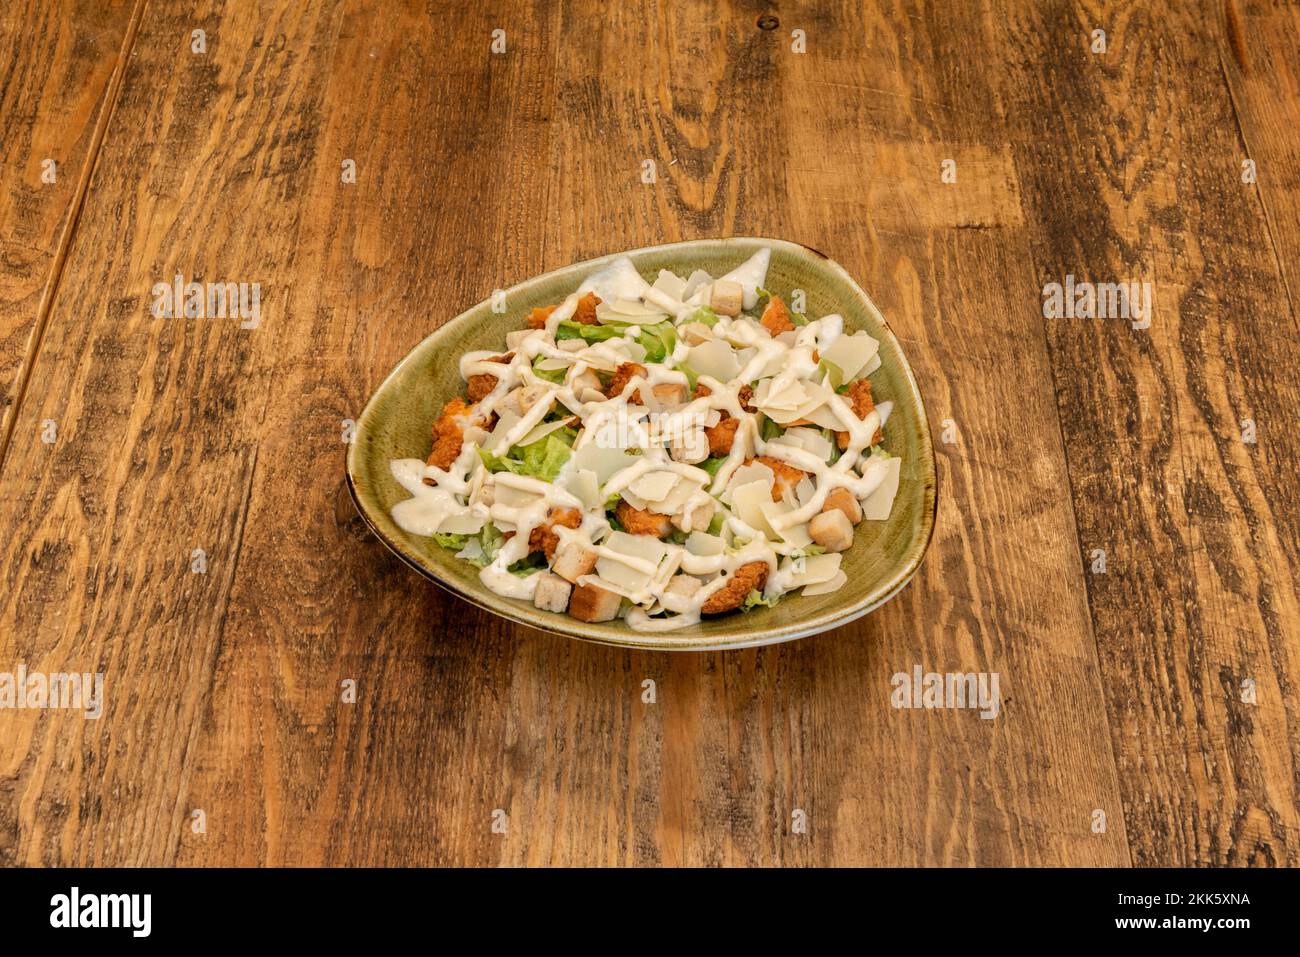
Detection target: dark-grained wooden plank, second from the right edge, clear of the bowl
<box><xmin>995</xmin><ymin>4</ymin><xmax>1300</xmax><ymax>865</ymax></box>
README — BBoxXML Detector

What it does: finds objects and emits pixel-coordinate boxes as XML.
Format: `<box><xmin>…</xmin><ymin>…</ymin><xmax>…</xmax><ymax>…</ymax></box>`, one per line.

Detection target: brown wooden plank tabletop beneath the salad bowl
<box><xmin>0</xmin><ymin>0</ymin><xmax>1300</xmax><ymax>865</ymax></box>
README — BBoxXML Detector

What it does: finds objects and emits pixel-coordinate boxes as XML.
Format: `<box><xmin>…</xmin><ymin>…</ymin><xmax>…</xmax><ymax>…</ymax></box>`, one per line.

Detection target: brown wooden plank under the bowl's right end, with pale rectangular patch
<box><xmin>780</xmin><ymin>4</ymin><xmax>1127</xmax><ymax>865</ymax></box>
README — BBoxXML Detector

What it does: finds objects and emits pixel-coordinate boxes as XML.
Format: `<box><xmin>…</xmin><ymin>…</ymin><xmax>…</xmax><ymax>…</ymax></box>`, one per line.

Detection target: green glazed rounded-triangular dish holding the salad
<box><xmin>347</xmin><ymin>238</ymin><xmax>937</xmax><ymax>651</ymax></box>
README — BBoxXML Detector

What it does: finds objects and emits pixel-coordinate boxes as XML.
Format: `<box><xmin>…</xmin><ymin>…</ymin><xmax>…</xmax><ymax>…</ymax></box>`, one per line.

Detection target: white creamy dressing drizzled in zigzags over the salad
<box><xmin>390</xmin><ymin>248</ymin><xmax>889</xmax><ymax>632</ymax></box>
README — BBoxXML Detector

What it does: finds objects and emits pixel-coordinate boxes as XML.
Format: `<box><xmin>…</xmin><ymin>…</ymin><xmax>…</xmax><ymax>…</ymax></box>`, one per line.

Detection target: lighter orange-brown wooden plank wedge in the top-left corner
<box><xmin>0</xmin><ymin>0</ymin><xmax>138</xmax><ymax>463</ymax></box>
